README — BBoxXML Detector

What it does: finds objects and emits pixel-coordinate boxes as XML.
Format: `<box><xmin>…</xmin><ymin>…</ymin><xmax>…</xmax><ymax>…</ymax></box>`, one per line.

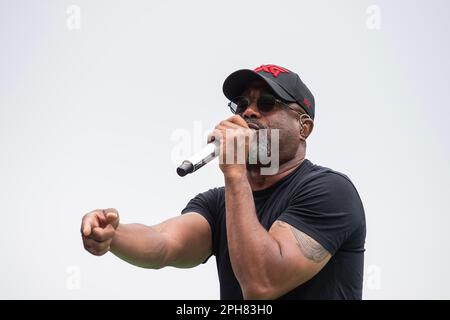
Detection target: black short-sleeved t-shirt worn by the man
<box><xmin>182</xmin><ymin>160</ymin><xmax>366</xmax><ymax>299</ymax></box>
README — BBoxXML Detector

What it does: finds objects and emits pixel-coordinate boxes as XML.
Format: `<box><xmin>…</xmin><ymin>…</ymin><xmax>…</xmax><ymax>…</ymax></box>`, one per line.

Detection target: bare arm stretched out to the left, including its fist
<box><xmin>81</xmin><ymin>209</ymin><xmax>212</xmax><ymax>269</ymax></box>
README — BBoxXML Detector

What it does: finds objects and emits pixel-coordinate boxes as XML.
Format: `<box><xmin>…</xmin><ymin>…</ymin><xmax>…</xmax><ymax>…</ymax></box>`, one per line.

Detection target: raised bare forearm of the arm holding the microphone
<box><xmin>225</xmin><ymin>171</ymin><xmax>281</xmax><ymax>298</ymax></box>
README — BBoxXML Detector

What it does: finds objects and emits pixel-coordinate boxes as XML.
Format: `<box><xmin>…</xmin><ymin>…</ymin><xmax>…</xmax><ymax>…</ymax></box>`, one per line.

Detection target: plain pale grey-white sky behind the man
<box><xmin>0</xmin><ymin>0</ymin><xmax>450</xmax><ymax>299</ymax></box>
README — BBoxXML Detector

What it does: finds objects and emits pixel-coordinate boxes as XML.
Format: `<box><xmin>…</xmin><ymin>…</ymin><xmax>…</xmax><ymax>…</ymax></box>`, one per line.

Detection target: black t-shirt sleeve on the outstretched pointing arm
<box><xmin>181</xmin><ymin>188</ymin><xmax>219</xmax><ymax>254</ymax></box>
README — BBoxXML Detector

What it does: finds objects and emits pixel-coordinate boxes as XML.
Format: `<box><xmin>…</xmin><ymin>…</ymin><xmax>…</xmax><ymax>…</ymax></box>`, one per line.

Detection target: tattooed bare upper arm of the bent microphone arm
<box><xmin>269</xmin><ymin>220</ymin><xmax>331</xmax><ymax>297</ymax></box>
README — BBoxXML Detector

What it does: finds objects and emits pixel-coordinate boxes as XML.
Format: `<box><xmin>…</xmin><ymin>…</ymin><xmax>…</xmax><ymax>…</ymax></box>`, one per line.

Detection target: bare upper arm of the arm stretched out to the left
<box><xmin>155</xmin><ymin>212</ymin><xmax>212</xmax><ymax>268</ymax></box>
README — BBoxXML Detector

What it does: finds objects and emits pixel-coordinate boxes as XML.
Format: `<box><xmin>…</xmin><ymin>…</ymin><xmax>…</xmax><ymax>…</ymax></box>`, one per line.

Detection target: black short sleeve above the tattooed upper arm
<box><xmin>278</xmin><ymin>172</ymin><xmax>364</xmax><ymax>255</ymax></box>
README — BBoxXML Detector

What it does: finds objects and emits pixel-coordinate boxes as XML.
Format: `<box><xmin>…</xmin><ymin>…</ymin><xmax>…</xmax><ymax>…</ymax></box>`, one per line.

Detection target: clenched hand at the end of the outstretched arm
<box><xmin>81</xmin><ymin>209</ymin><xmax>119</xmax><ymax>256</ymax></box>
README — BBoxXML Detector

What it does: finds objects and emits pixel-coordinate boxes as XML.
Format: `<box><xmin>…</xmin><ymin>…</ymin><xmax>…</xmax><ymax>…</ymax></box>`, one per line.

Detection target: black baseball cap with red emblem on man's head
<box><xmin>223</xmin><ymin>64</ymin><xmax>315</xmax><ymax>119</ymax></box>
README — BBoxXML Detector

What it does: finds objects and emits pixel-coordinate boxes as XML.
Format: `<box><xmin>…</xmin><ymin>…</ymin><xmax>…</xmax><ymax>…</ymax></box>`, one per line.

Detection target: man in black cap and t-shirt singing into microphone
<box><xmin>81</xmin><ymin>65</ymin><xmax>366</xmax><ymax>299</ymax></box>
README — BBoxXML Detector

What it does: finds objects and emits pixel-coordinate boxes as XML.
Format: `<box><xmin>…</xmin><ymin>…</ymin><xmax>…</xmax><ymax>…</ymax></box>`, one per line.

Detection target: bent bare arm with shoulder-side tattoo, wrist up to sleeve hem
<box><xmin>225</xmin><ymin>171</ymin><xmax>331</xmax><ymax>299</ymax></box>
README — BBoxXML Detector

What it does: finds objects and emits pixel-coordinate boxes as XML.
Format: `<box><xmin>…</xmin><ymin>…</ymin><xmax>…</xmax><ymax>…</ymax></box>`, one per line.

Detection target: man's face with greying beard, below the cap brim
<box><xmin>237</xmin><ymin>81</ymin><xmax>302</xmax><ymax>164</ymax></box>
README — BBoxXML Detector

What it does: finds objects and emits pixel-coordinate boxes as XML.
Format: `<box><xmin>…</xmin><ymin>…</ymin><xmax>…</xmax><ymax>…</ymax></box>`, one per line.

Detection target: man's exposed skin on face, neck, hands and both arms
<box><xmin>81</xmin><ymin>82</ymin><xmax>331</xmax><ymax>299</ymax></box>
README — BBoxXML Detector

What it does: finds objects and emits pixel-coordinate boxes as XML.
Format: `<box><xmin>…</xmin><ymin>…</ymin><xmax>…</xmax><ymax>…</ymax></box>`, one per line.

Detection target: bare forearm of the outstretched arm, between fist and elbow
<box><xmin>110</xmin><ymin>224</ymin><xmax>168</xmax><ymax>269</ymax></box>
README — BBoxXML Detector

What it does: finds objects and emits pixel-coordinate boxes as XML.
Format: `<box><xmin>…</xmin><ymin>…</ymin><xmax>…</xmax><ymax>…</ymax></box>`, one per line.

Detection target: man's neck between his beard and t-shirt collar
<box><xmin>247</xmin><ymin>152</ymin><xmax>305</xmax><ymax>191</ymax></box>
